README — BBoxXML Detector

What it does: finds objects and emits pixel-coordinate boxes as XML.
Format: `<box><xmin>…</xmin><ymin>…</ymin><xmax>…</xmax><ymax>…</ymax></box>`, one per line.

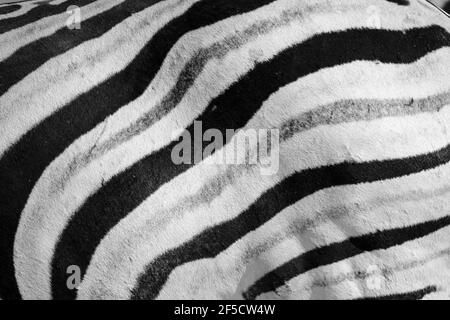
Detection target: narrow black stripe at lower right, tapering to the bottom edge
<box><xmin>243</xmin><ymin>216</ymin><xmax>450</xmax><ymax>299</ymax></box>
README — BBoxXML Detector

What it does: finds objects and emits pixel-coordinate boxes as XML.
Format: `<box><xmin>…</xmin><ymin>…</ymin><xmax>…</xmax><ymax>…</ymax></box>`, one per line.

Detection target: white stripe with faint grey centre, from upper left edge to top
<box><xmin>0</xmin><ymin>0</ymin><xmax>199</xmax><ymax>156</ymax></box>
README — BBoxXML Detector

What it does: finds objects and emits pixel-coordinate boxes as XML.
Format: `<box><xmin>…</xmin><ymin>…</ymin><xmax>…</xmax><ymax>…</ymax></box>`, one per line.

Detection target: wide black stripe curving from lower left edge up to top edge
<box><xmin>0</xmin><ymin>0</ymin><xmax>274</xmax><ymax>299</ymax></box>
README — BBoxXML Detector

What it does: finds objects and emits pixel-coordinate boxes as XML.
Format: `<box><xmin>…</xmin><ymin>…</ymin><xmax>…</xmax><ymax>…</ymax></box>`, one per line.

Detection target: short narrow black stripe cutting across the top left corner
<box><xmin>0</xmin><ymin>0</ymin><xmax>95</xmax><ymax>34</ymax></box>
